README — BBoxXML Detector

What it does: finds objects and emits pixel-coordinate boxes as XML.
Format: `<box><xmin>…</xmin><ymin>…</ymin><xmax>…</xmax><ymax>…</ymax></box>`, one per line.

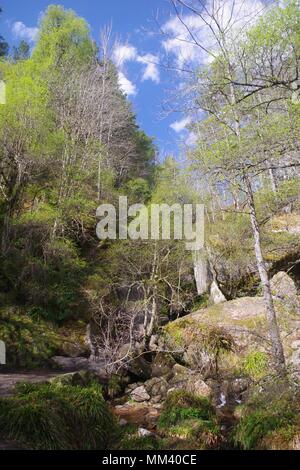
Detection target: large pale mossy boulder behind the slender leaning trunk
<box><xmin>164</xmin><ymin>298</ymin><xmax>300</xmax><ymax>381</ymax></box>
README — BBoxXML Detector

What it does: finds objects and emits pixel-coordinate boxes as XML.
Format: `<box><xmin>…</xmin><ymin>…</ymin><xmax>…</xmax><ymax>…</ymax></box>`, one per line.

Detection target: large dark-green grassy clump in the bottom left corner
<box><xmin>0</xmin><ymin>384</ymin><xmax>116</xmax><ymax>450</ymax></box>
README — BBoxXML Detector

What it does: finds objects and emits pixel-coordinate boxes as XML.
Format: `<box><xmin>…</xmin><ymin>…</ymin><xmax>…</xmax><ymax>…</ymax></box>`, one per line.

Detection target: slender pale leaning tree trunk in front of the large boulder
<box><xmin>244</xmin><ymin>177</ymin><xmax>286</xmax><ymax>376</ymax></box>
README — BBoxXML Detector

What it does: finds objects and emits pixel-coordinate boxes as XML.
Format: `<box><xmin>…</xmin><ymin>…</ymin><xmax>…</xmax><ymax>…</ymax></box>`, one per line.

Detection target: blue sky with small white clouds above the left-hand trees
<box><xmin>0</xmin><ymin>0</ymin><xmax>195</xmax><ymax>158</ymax></box>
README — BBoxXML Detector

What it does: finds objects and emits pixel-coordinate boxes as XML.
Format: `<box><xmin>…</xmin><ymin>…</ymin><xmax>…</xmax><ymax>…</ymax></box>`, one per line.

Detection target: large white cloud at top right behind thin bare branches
<box><xmin>162</xmin><ymin>0</ymin><xmax>266</xmax><ymax>68</ymax></box>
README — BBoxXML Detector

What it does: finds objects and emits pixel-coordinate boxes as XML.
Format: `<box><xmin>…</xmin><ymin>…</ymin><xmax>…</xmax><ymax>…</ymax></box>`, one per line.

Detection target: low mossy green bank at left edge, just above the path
<box><xmin>0</xmin><ymin>307</ymin><xmax>58</xmax><ymax>368</ymax></box>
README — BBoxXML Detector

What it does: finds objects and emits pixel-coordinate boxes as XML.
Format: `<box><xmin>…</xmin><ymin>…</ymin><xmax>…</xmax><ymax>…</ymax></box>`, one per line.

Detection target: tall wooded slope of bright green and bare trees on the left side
<box><xmin>0</xmin><ymin>1</ymin><xmax>155</xmax><ymax>334</ymax></box>
